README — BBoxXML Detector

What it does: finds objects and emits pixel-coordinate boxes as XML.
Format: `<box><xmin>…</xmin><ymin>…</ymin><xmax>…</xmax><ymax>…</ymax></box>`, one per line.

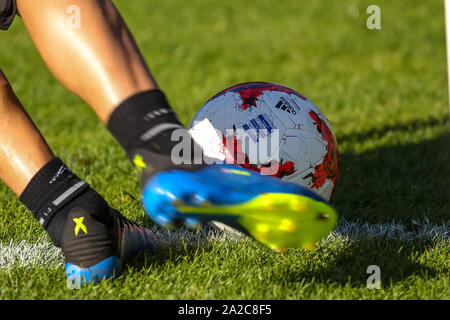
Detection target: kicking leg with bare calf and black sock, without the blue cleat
<box><xmin>17</xmin><ymin>0</ymin><xmax>198</xmax><ymax>175</ymax></box>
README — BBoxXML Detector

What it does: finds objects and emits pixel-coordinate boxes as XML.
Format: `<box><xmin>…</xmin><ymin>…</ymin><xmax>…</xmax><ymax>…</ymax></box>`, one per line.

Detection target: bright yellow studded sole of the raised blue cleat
<box><xmin>175</xmin><ymin>193</ymin><xmax>338</xmax><ymax>252</ymax></box>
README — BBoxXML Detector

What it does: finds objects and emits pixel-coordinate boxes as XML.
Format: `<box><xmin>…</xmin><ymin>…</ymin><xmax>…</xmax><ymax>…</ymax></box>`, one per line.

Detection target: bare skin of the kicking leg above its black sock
<box><xmin>17</xmin><ymin>0</ymin><xmax>157</xmax><ymax>123</ymax></box>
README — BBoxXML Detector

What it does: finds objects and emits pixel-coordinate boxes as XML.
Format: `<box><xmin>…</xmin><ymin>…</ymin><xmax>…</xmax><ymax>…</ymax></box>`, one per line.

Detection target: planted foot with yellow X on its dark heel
<box><xmin>61</xmin><ymin>203</ymin><xmax>156</xmax><ymax>285</ymax></box>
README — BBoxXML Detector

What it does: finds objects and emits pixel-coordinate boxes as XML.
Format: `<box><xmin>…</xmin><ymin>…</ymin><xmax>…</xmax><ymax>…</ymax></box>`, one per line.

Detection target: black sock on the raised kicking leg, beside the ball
<box><xmin>108</xmin><ymin>89</ymin><xmax>202</xmax><ymax>177</ymax></box>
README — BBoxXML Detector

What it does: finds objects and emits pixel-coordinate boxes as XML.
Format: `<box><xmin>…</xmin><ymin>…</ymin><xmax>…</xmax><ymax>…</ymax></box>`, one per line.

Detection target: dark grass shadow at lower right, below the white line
<box><xmin>280</xmin><ymin>239</ymin><xmax>439</xmax><ymax>288</ymax></box>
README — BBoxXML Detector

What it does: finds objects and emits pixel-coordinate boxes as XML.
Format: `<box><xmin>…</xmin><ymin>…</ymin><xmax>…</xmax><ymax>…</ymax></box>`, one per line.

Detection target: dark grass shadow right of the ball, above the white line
<box><xmin>332</xmin><ymin>121</ymin><xmax>450</xmax><ymax>223</ymax></box>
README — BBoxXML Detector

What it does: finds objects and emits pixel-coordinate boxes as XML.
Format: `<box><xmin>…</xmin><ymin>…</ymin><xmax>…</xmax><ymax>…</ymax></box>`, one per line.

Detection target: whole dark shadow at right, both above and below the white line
<box><xmin>286</xmin><ymin>119</ymin><xmax>450</xmax><ymax>287</ymax></box>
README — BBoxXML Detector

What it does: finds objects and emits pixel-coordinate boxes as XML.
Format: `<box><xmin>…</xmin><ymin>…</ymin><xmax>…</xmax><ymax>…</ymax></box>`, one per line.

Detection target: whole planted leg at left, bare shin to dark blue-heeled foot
<box><xmin>0</xmin><ymin>70</ymin><xmax>155</xmax><ymax>281</ymax></box>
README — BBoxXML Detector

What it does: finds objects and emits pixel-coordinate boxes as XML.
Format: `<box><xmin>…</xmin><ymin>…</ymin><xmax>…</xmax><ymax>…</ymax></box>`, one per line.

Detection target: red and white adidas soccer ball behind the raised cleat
<box><xmin>190</xmin><ymin>82</ymin><xmax>339</xmax><ymax>200</ymax></box>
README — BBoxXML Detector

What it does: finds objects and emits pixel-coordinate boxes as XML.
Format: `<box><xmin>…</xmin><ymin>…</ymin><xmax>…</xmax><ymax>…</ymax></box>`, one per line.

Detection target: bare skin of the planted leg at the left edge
<box><xmin>0</xmin><ymin>70</ymin><xmax>54</xmax><ymax>195</ymax></box>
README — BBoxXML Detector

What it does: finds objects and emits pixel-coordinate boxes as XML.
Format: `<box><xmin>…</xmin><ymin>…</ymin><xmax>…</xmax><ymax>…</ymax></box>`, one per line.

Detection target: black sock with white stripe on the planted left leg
<box><xmin>20</xmin><ymin>158</ymin><xmax>110</xmax><ymax>247</ymax></box>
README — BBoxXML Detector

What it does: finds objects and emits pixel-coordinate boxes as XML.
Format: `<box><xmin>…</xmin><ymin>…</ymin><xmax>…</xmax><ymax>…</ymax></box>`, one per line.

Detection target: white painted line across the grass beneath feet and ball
<box><xmin>0</xmin><ymin>219</ymin><xmax>450</xmax><ymax>270</ymax></box>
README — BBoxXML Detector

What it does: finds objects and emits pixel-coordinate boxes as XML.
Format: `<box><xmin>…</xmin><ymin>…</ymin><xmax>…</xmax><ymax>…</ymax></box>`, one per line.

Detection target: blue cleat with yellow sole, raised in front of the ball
<box><xmin>143</xmin><ymin>164</ymin><xmax>338</xmax><ymax>251</ymax></box>
